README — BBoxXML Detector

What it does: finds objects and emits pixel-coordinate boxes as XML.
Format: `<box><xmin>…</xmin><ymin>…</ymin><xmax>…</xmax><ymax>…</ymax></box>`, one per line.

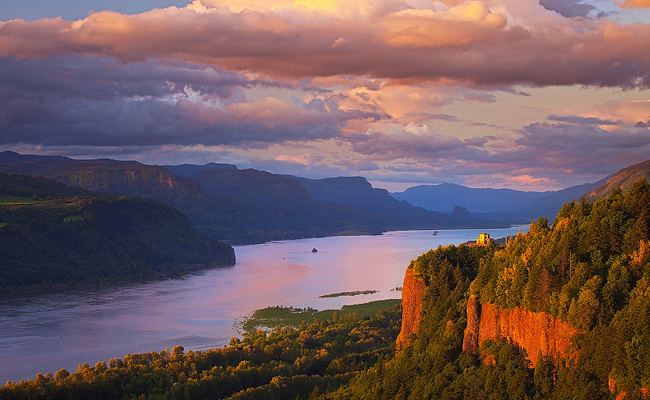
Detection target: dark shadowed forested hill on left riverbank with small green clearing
<box><xmin>0</xmin><ymin>174</ymin><xmax>234</xmax><ymax>293</ymax></box>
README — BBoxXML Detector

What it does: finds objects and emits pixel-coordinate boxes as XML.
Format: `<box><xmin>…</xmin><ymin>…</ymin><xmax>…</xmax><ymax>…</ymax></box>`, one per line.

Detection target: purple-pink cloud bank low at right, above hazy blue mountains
<box><xmin>322</xmin><ymin>117</ymin><xmax>650</xmax><ymax>190</ymax></box>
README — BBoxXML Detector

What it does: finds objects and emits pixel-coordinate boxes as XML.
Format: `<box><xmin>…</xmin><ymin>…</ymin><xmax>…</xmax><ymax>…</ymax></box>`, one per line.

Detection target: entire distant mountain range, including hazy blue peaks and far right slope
<box><xmin>0</xmin><ymin>152</ymin><xmax>650</xmax><ymax>244</ymax></box>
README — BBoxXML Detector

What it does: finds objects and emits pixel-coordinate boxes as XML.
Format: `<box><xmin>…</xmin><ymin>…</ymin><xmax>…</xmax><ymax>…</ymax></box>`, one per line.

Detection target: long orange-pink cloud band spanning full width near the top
<box><xmin>0</xmin><ymin>0</ymin><xmax>650</xmax><ymax>88</ymax></box>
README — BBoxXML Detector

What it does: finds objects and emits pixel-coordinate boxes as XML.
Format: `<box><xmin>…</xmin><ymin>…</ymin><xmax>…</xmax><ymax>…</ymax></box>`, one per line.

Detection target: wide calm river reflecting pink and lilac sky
<box><xmin>0</xmin><ymin>227</ymin><xmax>527</xmax><ymax>383</ymax></box>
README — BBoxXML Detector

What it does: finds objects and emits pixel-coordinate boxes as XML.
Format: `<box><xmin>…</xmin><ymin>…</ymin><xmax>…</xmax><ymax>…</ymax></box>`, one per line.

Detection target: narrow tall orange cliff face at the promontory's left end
<box><xmin>397</xmin><ymin>268</ymin><xmax>426</xmax><ymax>351</ymax></box>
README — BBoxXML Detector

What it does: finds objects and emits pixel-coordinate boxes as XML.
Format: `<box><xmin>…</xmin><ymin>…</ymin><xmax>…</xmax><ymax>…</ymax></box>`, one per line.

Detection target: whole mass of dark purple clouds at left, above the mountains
<box><xmin>0</xmin><ymin>56</ymin><xmax>382</xmax><ymax>147</ymax></box>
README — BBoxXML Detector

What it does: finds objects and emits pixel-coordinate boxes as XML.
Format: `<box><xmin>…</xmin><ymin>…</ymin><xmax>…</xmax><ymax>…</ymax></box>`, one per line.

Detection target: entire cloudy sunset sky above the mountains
<box><xmin>0</xmin><ymin>0</ymin><xmax>650</xmax><ymax>191</ymax></box>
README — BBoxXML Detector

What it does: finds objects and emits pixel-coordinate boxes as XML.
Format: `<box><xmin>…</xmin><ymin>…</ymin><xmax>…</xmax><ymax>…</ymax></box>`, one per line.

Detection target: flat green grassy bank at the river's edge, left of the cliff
<box><xmin>235</xmin><ymin>299</ymin><xmax>402</xmax><ymax>334</ymax></box>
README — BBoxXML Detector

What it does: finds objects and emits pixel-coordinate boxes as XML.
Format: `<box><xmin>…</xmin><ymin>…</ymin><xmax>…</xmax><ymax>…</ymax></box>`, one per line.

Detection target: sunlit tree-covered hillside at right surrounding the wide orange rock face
<box><xmin>327</xmin><ymin>180</ymin><xmax>650</xmax><ymax>399</ymax></box>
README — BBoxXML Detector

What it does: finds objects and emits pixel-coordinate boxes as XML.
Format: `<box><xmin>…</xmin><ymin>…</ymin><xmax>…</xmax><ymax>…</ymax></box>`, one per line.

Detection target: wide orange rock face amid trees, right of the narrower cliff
<box><xmin>463</xmin><ymin>297</ymin><xmax>579</xmax><ymax>365</ymax></box>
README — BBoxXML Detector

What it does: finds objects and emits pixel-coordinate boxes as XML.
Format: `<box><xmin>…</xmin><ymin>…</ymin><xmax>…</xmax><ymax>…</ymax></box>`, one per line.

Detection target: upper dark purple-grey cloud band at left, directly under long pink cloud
<box><xmin>0</xmin><ymin>56</ymin><xmax>249</xmax><ymax>100</ymax></box>
